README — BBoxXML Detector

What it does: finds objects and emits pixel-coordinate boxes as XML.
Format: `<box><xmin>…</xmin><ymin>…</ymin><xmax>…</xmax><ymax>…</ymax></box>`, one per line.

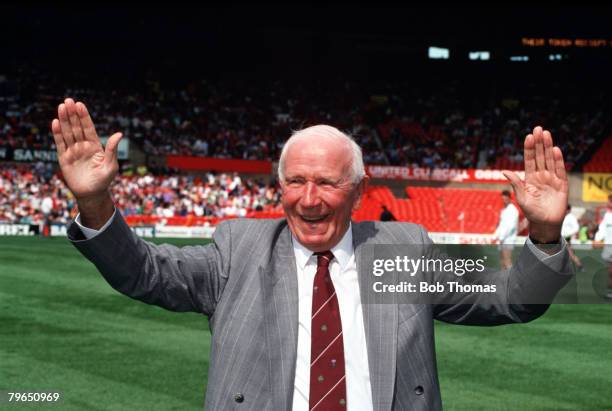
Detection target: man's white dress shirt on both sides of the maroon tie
<box><xmin>292</xmin><ymin>226</ymin><xmax>373</xmax><ymax>411</ymax></box>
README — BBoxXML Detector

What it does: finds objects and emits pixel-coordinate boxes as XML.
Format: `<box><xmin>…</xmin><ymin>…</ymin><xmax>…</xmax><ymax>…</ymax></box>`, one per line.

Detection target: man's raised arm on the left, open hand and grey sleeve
<box><xmin>51</xmin><ymin>98</ymin><xmax>231</xmax><ymax>315</ymax></box>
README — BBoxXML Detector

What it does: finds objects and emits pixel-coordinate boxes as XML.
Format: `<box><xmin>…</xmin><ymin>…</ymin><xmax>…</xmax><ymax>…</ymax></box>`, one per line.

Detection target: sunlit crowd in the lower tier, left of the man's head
<box><xmin>0</xmin><ymin>162</ymin><xmax>280</xmax><ymax>225</ymax></box>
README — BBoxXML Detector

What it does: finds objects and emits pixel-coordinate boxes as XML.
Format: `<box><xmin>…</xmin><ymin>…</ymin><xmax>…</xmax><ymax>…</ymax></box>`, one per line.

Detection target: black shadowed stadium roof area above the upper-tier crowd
<box><xmin>0</xmin><ymin>2</ymin><xmax>612</xmax><ymax>77</ymax></box>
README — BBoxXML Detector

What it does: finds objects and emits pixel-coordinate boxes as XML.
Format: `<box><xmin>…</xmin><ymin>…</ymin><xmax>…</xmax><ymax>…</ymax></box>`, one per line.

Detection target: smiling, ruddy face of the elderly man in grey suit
<box><xmin>281</xmin><ymin>136</ymin><xmax>367</xmax><ymax>252</ymax></box>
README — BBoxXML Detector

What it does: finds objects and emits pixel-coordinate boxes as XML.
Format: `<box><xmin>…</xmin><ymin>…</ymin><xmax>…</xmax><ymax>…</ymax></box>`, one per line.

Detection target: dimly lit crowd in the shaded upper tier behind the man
<box><xmin>0</xmin><ymin>68</ymin><xmax>611</xmax><ymax>168</ymax></box>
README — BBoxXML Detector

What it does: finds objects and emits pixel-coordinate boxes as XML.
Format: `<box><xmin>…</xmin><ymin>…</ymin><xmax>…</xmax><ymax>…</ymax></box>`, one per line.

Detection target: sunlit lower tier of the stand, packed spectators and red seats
<box><xmin>0</xmin><ymin>163</ymin><xmax>516</xmax><ymax>238</ymax></box>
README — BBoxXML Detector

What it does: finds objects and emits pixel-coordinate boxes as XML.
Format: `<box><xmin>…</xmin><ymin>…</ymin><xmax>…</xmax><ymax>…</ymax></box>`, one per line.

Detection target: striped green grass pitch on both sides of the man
<box><xmin>0</xmin><ymin>237</ymin><xmax>612</xmax><ymax>411</ymax></box>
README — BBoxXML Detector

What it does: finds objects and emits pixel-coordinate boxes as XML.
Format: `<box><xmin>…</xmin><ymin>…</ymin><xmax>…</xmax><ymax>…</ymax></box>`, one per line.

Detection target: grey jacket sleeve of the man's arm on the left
<box><xmin>68</xmin><ymin>213</ymin><xmax>231</xmax><ymax>316</ymax></box>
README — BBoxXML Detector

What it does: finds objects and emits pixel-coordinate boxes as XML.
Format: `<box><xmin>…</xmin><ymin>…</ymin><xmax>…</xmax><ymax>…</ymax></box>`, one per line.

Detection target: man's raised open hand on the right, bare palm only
<box><xmin>503</xmin><ymin>126</ymin><xmax>569</xmax><ymax>242</ymax></box>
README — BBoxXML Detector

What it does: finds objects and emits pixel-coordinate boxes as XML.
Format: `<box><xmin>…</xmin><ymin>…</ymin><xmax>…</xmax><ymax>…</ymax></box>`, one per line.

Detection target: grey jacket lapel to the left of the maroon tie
<box><xmin>259</xmin><ymin>225</ymin><xmax>298</xmax><ymax>410</ymax></box>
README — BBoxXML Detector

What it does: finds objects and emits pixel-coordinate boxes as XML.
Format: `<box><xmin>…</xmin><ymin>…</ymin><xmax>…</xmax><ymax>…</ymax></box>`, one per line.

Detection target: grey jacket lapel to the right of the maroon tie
<box><xmin>352</xmin><ymin>222</ymin><xmax>398</xmax><ymax>411</ymax></box>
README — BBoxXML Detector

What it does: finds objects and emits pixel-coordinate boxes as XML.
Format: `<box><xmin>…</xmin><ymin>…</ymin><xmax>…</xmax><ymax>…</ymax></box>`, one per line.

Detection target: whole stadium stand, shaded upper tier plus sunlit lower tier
<box><xmin>0</xmin><ymin>66</ymin><xmax>612</xmax><ymax>240</ymax></box>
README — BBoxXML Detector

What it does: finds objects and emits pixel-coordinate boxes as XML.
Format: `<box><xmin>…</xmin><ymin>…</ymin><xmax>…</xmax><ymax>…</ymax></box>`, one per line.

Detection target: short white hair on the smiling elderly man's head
<box><xmin>278</xmin><ymin>124</ymin><xmax>365</xmax><ymax>184</ymax></box>
